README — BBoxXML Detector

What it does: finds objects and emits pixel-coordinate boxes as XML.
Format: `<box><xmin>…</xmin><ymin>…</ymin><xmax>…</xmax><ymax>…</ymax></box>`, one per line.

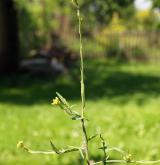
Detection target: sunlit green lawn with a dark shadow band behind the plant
<box><xmin>0</xmin><ymin>59</ymin><xmax>160</xmax><ymax>165</ymax></box>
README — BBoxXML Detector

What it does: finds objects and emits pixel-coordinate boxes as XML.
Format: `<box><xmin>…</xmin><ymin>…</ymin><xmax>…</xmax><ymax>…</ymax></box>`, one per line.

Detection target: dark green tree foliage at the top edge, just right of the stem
<box><xmin>81</xmin><ymin>0</ymin><xmax>134</xmax><ymax>24</ymax></box>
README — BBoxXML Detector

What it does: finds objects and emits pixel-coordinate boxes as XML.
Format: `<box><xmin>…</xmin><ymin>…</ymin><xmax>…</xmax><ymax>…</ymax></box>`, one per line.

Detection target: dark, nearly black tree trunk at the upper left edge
<box><xmin>0</xmin><ymin>0</ymin><xmax>19</xmax><ymax>74</ymax></box>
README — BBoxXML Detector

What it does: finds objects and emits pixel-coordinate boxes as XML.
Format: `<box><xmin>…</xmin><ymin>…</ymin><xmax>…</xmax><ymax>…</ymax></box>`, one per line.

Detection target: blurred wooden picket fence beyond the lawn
<box><xmin>65</xmin><ymin>31</ymin><xmax>160</xmax><ymax>61</ymax></box>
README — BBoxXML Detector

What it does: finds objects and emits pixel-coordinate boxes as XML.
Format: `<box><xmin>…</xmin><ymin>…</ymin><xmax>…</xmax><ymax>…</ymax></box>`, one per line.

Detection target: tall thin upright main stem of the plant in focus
<box><xmin>77</xmin><ymin>7</ymin><xmax>90</xmax><ymax>165</ymax></box>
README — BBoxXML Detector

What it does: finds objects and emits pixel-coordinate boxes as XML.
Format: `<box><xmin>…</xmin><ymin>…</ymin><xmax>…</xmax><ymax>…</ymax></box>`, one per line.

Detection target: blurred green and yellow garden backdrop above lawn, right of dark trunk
<box><xmin>11</xmin><ymin>0</ymin><xmax>160</xmax><ymax>63</ymax></box>
